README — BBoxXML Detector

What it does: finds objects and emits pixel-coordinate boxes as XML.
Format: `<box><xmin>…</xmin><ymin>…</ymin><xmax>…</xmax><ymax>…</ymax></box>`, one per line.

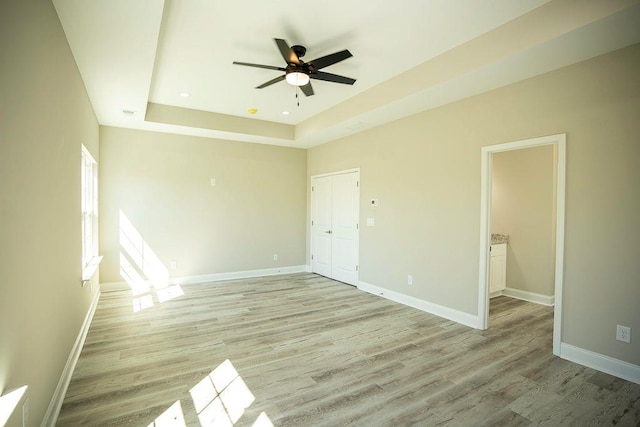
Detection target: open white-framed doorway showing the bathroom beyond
<box><xmin>478</xmin><ymin>134</ymin><xmax>566</xmax><ymax>354</ymax></box>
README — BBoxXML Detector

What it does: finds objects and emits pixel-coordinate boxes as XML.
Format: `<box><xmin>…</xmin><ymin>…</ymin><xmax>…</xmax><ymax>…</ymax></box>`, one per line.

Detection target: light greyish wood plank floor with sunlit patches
<box><xmin>58</xmin><ymin>274</ymin><xmax>640</xmax><ymax>426</ymax></box>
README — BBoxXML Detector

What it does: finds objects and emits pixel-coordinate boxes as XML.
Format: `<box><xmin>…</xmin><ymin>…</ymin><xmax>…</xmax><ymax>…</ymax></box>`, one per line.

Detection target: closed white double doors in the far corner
<box><xmin>311</xmin><ymin>172</ymin><xmax>360</xmax><ymax>285</ymax></box>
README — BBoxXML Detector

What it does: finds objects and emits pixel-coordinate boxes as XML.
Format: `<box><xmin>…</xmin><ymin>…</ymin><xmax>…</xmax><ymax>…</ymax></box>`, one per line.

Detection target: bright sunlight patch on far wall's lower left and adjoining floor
<box><xmin>119</xmin><ymin>209</ymin><xmax>184</xmax><ymax>313</ymax></box>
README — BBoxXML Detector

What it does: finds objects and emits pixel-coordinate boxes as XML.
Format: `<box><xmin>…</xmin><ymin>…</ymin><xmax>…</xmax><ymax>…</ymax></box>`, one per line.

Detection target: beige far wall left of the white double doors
<box><xmin>100</xmin><ymin>127</ymin><xmax>306</xmax><ymax>283</ymax></box>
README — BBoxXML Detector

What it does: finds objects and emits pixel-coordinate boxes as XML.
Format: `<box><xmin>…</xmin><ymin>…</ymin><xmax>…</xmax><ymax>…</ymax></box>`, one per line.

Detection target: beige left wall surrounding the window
<box><xmin>0</xmin><ymin>1</ymin><xmax>99</xmax><ymax>426</ymax></box>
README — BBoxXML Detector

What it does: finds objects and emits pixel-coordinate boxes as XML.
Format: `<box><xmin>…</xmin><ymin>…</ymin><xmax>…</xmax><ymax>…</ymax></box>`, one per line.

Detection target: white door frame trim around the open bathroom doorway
<box><xmin>478</xmin><ymin>133</ymin><xmax>567</xmax><ymax>356</ymax></box>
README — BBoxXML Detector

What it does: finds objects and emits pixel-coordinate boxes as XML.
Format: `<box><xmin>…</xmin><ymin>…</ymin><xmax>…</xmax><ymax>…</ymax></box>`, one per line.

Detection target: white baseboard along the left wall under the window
<box><xmin>41</xmin><ymin>290</ymin><xmax>100</xmax><ymax>427</ymax></box>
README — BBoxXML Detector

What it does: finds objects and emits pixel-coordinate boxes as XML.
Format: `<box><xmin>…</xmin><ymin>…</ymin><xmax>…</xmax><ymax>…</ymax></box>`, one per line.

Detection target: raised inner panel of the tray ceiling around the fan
<box><xmin>150</xmin><ymin>0</ymin><xmax>546</xmax><ymax>124</ymax></box>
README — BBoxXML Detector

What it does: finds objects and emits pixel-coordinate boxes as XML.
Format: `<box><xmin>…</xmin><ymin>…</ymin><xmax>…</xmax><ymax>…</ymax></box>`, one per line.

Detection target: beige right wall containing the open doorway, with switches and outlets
<box><xmin>307</xmin><ymin>45</ymin><xmax>640</xmax><ymax>365</ymax></box>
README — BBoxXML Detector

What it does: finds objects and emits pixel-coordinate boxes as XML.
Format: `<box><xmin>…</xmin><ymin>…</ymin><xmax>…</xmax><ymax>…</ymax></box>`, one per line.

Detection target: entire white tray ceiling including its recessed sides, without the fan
<box><xmin>53</xmin><ymin>0</ymin><xmax>640</xmax><ymax>148</ymax></box>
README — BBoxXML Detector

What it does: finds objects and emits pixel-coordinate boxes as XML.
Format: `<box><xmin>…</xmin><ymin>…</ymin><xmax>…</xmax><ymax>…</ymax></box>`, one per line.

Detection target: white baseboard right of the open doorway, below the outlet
<box><xmin>560</xmin><ymin>343</ymin><xmax>640</xmax><ymax>384</ymax></box>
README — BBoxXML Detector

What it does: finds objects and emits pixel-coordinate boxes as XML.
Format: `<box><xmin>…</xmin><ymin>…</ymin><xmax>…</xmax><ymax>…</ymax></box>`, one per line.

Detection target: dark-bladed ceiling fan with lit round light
<box><xmin>233</xmin><ymin>39</ymin><xmax>356</xmax><ymax>96</ymax></box>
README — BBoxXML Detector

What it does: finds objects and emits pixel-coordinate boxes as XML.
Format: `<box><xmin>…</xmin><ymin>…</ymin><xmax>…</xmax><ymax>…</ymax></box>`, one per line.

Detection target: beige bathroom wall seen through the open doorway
<box><xmin>491</xmin><ymin>145</ymin><xmax>556</xmax><ymax>296</ymax></box>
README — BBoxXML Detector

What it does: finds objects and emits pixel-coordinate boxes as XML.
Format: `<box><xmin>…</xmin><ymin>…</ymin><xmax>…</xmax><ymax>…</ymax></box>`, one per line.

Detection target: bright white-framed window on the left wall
<box><xmin>81</xmin><ymin>145</ymin><xmax>98</xmax><ymax>269</ymax></box>
